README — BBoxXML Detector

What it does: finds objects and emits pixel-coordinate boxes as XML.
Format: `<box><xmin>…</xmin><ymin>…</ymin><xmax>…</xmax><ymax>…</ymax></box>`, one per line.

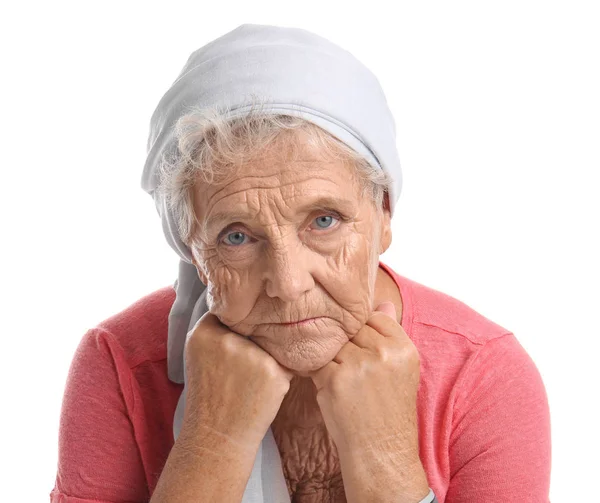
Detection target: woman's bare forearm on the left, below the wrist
<box><xmin>150</xmin><ymin>424</ymin><xmax>258</xmax><ymax>503</ymax></box>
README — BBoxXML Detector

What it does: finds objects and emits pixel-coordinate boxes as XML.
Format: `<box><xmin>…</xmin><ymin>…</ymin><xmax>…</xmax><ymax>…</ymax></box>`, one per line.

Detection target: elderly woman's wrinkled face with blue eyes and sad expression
<box><xmin>192</xmin><ymin>132</ymin><xmax>391</xmax><ymax>375</ymax></box>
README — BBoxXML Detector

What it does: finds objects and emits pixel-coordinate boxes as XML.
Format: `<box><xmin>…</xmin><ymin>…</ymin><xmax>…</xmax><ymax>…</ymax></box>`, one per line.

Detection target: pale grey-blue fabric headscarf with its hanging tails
<box><xmin>142</xmin><ymin>24</ymin><xmax>402</xmax><ymax>503</ymax></box>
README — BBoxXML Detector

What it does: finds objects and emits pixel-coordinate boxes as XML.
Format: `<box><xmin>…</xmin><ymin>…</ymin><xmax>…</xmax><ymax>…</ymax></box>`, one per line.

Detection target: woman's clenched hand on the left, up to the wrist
<box><xmin>182</xmin><ymin>313</ymin><xmax>294</xmax><ymax>450</ymax></box>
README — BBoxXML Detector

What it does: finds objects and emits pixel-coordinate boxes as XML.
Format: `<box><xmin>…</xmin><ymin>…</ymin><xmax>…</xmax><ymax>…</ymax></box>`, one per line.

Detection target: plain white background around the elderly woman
<box><xmin>0</xmin><ymin>0</ymin><xmax>600</xmax><ymax>503</ymax></box>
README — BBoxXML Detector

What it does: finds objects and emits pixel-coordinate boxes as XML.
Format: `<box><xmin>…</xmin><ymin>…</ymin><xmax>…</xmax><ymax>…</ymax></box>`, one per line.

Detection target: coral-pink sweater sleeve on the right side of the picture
<box><xmin>445</xmin><ymin>333</ymin><xmax>551</xmax><ymax>503</ymax></box>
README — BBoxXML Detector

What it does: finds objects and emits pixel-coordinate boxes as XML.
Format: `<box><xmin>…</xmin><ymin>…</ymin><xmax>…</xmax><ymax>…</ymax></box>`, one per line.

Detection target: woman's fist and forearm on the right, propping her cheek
<box><xmin>310</xmin><ymin>302</ymin><xmax>429</xmax><ymax>502</ymax></box>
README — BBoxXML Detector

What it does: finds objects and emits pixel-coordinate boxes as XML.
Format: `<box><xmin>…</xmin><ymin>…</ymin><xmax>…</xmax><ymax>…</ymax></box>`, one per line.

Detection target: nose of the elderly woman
<box><xmin>265</xmin><ymin>241</ymin><xmax>315</xmax><ymax>302</ymax></box>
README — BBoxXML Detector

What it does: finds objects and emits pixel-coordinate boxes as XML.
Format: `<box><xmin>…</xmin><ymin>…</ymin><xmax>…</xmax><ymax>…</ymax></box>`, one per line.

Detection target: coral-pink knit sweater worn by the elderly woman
<box><xmin>50</xmin><ymin>263</ymin><xmax>551</xmax><ymax>503</ymax></box>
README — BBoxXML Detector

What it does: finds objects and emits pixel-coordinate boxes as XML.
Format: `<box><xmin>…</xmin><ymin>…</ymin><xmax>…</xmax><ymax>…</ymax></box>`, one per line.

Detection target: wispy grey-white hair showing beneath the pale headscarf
<box><xmin>156</xmin><ymin>105</ymin><xmax>392</xmax><ymax>250</ymax></box>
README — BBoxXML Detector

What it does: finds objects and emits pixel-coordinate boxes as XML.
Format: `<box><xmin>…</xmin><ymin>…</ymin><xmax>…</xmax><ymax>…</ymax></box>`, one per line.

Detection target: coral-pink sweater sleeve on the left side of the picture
<box><xmin>50</xmin><ymin>328</ymin><xmax>150</xmax><ymax>503</ymax></box>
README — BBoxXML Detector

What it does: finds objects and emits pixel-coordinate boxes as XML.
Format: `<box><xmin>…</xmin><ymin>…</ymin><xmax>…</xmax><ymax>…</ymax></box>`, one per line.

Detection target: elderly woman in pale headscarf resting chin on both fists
<box><xmin>51</xmin><ymin>25</ymin><xmax>550</xmax><ymax>503</ymax></box>
